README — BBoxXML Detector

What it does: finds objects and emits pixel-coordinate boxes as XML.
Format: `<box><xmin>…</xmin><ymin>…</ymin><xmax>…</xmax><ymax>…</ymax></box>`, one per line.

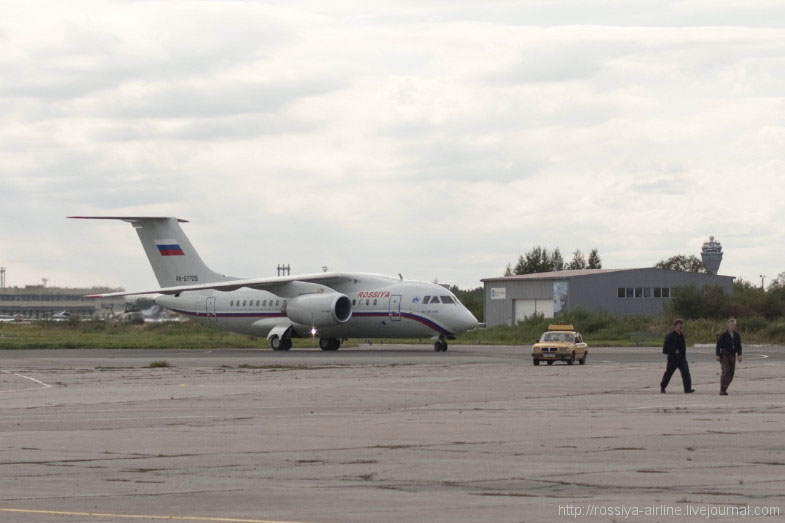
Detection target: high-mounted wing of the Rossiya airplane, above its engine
<box><xmin>86</xmin><ymin>273</ymin><xmax>357</xmax><ymax>298</ymax></box>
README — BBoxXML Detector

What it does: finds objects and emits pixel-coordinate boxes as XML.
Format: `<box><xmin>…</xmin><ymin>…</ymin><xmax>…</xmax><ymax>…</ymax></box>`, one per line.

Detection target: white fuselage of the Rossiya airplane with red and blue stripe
<box><xmin>155</xmin><ymin>274</ymin><xmax>477</xmax><ymax>338</ymax></box>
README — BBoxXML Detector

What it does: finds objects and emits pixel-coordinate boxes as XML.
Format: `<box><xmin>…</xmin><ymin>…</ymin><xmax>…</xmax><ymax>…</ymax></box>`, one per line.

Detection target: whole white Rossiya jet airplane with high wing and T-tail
<box><xmin>69</xmin><ymin>216</ymin><xmax>479</xmax><ymax>352</ymax></box>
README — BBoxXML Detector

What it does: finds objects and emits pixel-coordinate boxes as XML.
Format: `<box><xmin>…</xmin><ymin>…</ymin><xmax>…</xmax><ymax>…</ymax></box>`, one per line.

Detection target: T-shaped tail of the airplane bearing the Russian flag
<box><xmin>69</xmin><ymin>216</ymin><xmax>234</xmax><ymax>287</ymax></box>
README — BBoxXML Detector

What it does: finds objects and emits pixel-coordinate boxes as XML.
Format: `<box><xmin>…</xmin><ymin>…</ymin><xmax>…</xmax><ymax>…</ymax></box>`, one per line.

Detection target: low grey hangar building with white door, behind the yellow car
<box><xmin>482</xmin><ymin>268</ymin><xmax>734</xmax><ymax>327</ymax></box>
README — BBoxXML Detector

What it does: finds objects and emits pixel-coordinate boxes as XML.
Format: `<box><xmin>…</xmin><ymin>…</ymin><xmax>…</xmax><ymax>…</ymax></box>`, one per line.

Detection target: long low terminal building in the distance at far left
<box><xmin>0</xmin><ymin>285</ymin><xmax>125</xmax><ymax>320</ymax></box>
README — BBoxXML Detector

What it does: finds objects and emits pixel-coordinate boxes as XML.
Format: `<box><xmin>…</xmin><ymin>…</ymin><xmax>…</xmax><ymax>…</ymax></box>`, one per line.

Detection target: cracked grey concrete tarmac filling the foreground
<box><xmin>0</xmin><ymin>345</ymin><xmax>785</xmax><ymax>522</ymax></box>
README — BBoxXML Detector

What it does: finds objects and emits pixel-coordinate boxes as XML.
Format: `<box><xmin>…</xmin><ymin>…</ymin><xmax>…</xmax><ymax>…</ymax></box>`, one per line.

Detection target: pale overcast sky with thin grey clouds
<box><xmin>0</xmin><ymin>0</ymin><xmax>785</xmax><ymax>289</ymax></box>
